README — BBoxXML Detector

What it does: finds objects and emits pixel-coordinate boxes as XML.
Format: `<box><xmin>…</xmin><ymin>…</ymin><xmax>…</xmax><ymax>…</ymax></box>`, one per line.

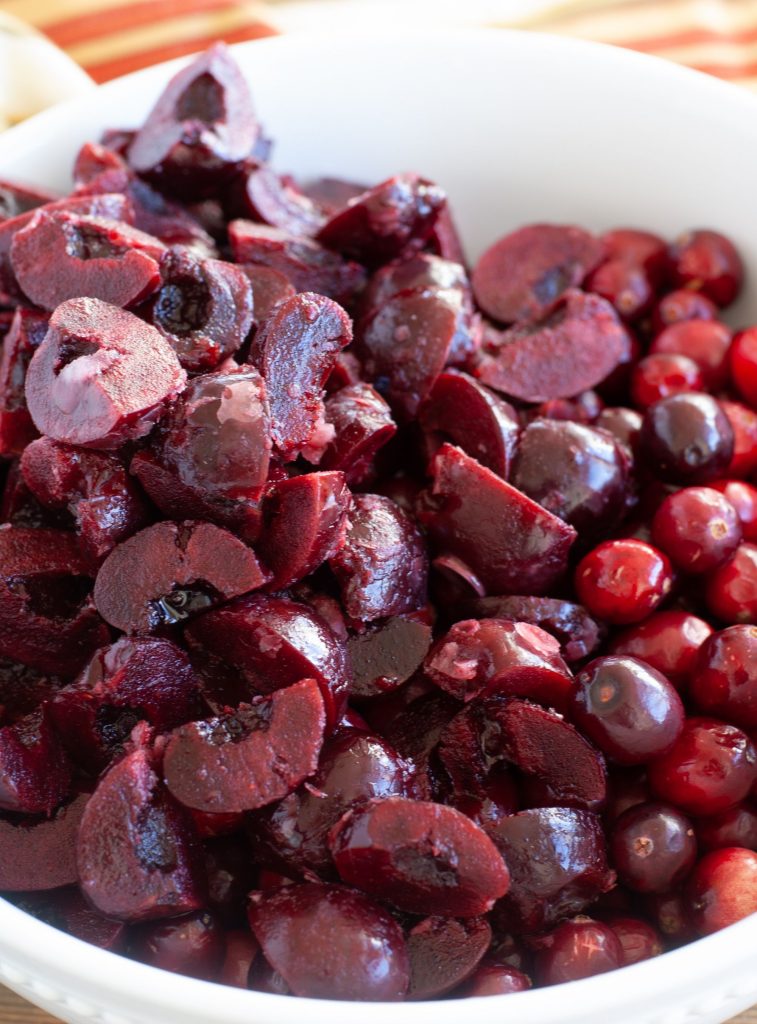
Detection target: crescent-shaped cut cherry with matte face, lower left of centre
<box><xmin>163</xmin><ymin>679</ymin><xmax>326</xmax><ymax>814</ymax></box>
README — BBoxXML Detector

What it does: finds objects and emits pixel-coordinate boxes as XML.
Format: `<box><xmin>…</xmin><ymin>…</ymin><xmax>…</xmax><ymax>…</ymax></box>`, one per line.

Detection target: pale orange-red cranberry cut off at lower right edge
<box><xmin>687</xmin><ymin>846</ymin><xmax>757</xmax><ymax>935</ymax></box>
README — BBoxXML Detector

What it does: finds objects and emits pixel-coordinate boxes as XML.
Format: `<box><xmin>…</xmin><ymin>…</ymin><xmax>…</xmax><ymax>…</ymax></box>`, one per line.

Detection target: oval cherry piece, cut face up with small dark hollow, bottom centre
<box><xmin>329</xmin><ymin>797</ymin><xmax>510</xmax><ymax>918</ymax></box>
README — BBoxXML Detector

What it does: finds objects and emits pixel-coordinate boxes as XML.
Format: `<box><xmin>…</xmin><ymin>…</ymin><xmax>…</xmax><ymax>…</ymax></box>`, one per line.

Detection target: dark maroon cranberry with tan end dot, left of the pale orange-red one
<box><xmin>609</xmin><ymin>803</ymin><xmax>697</xmax><ymax>893</ymax></box>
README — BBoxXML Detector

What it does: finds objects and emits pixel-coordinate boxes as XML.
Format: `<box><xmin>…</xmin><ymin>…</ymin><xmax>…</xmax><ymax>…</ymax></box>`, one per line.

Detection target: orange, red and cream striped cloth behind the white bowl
<box><xmin>0</xmin><ymin>0</ymin><xmax>757</xmax><ymax>89</ymax></box>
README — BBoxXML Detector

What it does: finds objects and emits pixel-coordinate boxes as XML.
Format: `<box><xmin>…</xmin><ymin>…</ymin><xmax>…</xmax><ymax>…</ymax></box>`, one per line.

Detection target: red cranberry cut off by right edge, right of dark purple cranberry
<box><xmin>689</xmin><ymin>626</ymin><xmax>757</xmax><ymax>730</ymax></box>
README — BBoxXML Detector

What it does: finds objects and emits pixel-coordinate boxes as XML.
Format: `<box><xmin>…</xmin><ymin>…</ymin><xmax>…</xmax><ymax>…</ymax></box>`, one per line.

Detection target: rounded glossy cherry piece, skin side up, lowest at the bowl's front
<box><xmin>249</xmin><ymin>885</ymin><xmax>410</xmax><ymax>1002</ymax></box>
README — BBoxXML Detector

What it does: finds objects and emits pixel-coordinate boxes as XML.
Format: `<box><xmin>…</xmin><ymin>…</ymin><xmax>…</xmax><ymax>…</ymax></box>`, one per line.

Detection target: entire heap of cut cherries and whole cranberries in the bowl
<box><xmin>0</xmin><ymin>46</ymin><xmax>757</xmax><ymax>1000</ymax></box>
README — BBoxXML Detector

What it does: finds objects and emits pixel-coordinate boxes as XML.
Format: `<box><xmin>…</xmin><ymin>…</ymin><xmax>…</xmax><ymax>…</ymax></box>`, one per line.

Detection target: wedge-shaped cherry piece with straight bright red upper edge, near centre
<box><xmin>418</xmin><ymin>444</ymin><xmax>577</xmax><ymax>594</ymax></box>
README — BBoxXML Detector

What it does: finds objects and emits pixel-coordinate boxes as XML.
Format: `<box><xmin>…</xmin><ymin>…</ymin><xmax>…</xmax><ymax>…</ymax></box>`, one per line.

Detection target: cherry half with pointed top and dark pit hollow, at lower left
<box><xmin>77</xmin><ymin>749</ymin><xmax>206</xmax><ymax>922</ymax></box>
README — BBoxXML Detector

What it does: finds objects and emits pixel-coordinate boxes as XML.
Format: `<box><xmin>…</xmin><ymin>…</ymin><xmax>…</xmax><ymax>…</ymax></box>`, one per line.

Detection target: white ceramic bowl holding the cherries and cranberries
<box><xmin>0</xmin><ymin>31</ymin><xmax>757</xmax><ymax>1024</ymax></box>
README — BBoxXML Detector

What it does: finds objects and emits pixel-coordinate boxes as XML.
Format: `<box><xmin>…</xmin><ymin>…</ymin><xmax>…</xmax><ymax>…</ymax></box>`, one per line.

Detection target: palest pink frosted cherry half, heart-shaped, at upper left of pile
<box><xmin>27</xmin><ymin>298</ymin><xmax>186</xmax><ymax>449</ymax></box>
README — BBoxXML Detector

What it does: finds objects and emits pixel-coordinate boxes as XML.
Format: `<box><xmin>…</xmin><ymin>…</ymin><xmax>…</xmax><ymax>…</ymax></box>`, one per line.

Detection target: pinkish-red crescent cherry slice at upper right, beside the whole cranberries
<box><xmin>476</xmin><ymin>289</ymin><xmax>628</xmax><ymax>401</ymax></box>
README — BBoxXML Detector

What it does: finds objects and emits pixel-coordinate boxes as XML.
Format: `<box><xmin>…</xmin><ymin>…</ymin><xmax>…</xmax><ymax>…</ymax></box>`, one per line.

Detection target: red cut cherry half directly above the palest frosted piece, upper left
<box><xmin>10</xmin><ymin>208</ymin><xmax>166</xmax><ymax>311</ymax></box>
